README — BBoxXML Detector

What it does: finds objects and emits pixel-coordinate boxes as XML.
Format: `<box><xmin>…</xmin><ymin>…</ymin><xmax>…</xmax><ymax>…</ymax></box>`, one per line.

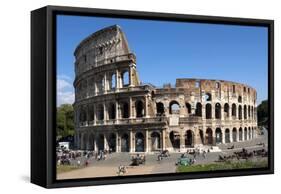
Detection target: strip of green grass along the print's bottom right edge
<box><xmin>177</xmin><ymin>160</ymin><xmax>268</xmax><ymax>172</ymax></box>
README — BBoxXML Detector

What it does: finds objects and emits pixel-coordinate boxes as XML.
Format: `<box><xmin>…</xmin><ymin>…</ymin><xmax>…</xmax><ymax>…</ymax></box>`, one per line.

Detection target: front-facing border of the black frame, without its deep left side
<box><xmin>31</xmin><ymin>6</ymin><xmax>274</xmax><ymax>188</ymax></box>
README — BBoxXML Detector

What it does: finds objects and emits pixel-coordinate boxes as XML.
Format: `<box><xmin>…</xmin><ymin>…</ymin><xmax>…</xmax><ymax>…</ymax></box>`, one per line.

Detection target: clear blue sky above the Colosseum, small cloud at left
<box><xmin>57</xmin><ymin>15</ymin><xmax>268</xmax><ymax>105</ymax></box>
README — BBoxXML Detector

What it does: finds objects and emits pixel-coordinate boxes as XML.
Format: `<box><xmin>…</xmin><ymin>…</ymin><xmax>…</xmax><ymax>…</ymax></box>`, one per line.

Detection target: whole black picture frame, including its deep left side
<box><xmin>31</xmin><ymin>6</ymin><xmax>274</xmax><ymax>188</ymax></box>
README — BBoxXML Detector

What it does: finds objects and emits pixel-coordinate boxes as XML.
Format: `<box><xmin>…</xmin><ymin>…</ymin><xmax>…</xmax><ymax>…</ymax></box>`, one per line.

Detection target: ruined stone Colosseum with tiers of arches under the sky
<box><xmin>73</xmin><ymin>25</ymin><xmax>257</xmax><ymax>153</ymax></box>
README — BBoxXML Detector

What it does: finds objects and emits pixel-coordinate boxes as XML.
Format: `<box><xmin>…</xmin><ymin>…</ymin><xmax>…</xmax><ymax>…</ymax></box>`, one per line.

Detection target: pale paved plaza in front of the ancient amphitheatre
<box><xmin>57</xmin><ymin>136</ymin><xmax>267</xmax><ymax>179</ymax></box>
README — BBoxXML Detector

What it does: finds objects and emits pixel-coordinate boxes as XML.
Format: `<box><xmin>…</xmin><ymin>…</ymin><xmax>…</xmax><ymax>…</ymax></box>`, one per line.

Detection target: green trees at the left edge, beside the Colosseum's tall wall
<box><xmin>56</xmin><ymin>104</ymin><xmax>74</xmax><ymax>138</ymax></box>
